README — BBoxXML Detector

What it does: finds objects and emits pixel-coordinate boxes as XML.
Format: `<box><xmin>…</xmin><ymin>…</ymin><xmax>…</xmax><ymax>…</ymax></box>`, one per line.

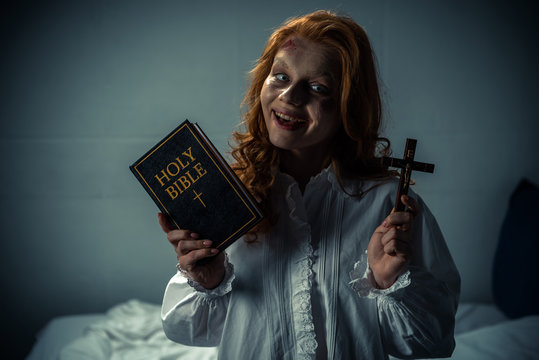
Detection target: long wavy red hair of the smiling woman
<box><xmin>232</xmin><ymin>11</ymin><xmax>390</xmax><ymax>222</ymax></box>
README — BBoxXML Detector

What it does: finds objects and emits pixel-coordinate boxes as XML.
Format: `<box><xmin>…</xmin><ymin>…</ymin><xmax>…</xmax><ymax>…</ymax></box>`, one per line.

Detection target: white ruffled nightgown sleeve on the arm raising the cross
<box><xmin>350</xmin><ymin>195</ymin><xmax>460</xmax><ymax>358</ymax></box>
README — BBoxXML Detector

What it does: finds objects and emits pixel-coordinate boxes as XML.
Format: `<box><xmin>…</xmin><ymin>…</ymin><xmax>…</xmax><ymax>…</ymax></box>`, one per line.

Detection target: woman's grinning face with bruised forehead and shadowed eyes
<box><xmin>260</xmin><ymin>36</ymin><xmax>341</xmax><ymax>159</ymax></box>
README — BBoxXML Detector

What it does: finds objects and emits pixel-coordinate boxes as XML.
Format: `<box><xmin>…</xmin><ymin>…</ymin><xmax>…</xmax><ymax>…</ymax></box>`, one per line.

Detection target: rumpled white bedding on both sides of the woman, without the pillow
<box><xmin>27</xmin><ymin>300</ymin><xmax>539</xmax><ymax>360</ymax></box>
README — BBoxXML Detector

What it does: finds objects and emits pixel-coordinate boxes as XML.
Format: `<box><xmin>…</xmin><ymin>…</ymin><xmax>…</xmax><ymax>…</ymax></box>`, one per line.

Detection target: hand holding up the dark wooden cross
<box><xmin>367</xmin><ymin>195</ymin><xmax>420</xmax><ymax>289</ymax></box>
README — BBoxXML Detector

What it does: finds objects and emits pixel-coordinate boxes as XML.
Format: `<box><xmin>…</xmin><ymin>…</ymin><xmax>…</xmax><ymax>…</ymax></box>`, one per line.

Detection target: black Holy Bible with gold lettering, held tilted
<box><xmin>129</xmin><ymin>120</ymin><xmax>263</xmax><ymax>250</ymax></box>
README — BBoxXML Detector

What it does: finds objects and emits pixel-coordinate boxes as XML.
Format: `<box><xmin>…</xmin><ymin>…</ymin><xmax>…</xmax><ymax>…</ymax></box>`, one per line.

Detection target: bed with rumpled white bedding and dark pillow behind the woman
<box><xmin>27</xmin><ymin>179</ymin><xmax>539</xmax><ymax>360</ymax></box>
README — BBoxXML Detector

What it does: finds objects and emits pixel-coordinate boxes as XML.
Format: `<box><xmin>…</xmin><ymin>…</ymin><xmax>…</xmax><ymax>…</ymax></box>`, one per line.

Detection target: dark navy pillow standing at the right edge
<box><xmin>492</xmin><ymin>179</ymin><xmax>539</xmax><ymax>318</ymax></box>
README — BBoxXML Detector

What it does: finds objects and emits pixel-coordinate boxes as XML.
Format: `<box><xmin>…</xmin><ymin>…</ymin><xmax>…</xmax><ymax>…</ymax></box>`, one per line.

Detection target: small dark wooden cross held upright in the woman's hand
<box><xmin>383</xmin><ymin>139</ymin><xmax>434</xmax><ymax>211</ymax></box>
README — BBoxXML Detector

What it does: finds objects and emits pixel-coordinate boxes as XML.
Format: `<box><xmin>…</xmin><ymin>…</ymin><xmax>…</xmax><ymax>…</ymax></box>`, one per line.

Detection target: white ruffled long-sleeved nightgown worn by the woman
<box><xmin>162</xmin><ymin>168</ymin><xmax>460</xmax><ymax>360</ymax></box>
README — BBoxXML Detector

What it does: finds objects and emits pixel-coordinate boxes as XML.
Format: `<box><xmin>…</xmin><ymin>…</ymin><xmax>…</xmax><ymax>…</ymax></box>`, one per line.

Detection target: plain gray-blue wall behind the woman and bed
<box><xmin>0</xmin><ymin>0</ymin><xmax>539</xmax><ymax>356</ymax></box>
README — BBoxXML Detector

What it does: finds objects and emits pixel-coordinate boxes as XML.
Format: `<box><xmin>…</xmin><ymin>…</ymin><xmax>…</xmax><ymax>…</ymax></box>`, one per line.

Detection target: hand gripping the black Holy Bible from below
<box><xmin>158</xmin><ymin>213</ymin><xmax>225</xmax><ymax>289</ymax></box>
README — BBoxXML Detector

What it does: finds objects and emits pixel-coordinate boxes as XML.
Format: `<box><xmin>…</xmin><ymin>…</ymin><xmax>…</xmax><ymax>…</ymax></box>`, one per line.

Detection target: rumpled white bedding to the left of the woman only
<box><xmin>27</xmin><ymin>299</ymin><xmax>217</xmax><ymax>360</ymax></box>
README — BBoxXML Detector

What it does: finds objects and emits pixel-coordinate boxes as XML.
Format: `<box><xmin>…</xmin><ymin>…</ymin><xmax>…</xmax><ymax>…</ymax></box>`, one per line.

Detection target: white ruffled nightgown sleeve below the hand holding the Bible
<box><xmin>161</xmin><ymin>252</ymin><xmax>235</xmax><ymax>346</ymax></box>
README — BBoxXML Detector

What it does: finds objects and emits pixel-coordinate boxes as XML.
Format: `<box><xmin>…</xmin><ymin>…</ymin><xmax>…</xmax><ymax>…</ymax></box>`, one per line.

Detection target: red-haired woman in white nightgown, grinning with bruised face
<box><xmin>159</xmin><ymin>11</ymin><xmax>460</xmax><ymax>359</ymax></box>
